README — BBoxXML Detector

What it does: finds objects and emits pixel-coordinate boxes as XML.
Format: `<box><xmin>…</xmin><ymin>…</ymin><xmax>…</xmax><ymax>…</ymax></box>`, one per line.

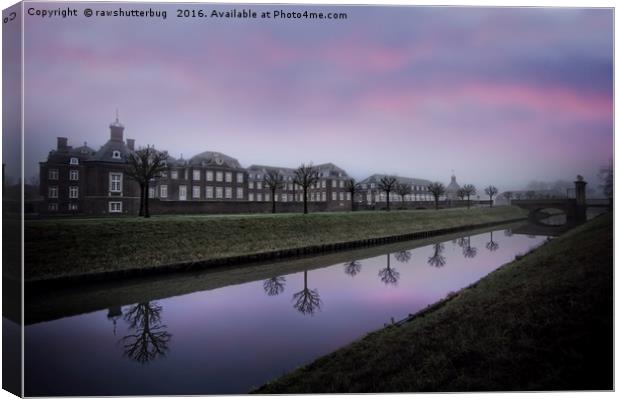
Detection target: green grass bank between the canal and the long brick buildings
<box><xmin>24</xmin><ymin>207</ymin><xmax>524</xmax><ymax>281</ymax></box>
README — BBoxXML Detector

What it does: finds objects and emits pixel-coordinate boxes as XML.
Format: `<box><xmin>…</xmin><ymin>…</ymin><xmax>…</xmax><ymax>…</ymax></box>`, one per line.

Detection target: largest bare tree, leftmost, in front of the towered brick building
<box><xmin>126</xmin><ymin>146</ymin><xmax>168</xmax><ymax>218</ymax></box>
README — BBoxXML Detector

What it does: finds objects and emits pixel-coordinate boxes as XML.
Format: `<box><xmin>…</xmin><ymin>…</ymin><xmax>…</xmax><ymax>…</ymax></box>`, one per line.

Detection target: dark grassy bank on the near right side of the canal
<box><xmin>257</xmin><ymin>215</ymin><xmax>613</xmax><ymax>393</ymax></box>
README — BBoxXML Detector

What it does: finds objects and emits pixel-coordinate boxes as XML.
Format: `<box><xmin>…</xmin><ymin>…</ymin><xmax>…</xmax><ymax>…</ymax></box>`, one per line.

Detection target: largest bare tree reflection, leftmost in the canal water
<box><xmin>121</xmin><ymin>302</ymin><xmax>172</xmax><ymax>364</ymax></box>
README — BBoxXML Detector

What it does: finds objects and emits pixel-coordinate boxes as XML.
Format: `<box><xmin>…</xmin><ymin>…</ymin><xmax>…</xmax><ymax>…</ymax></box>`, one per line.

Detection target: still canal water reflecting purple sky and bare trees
<box><xmin>25</xmin><ymin>230</ymin><xmax>546</xmax><ymax>396</ymax></box>
